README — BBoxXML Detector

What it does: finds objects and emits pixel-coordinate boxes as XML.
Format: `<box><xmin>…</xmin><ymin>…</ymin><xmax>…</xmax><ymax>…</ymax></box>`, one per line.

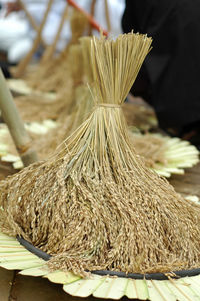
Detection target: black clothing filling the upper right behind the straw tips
<box><xmin>122</xmin><ymin>0</ymin><xmax>200</xmax><ymax>128</ymax></box>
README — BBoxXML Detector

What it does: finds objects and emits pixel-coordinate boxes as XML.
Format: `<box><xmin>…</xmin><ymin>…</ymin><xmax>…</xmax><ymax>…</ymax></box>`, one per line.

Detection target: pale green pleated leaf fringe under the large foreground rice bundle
<box><xmin>0</xmin><ymin>233</ymin><xmax>200</xmax><ymax>301</ymax></box>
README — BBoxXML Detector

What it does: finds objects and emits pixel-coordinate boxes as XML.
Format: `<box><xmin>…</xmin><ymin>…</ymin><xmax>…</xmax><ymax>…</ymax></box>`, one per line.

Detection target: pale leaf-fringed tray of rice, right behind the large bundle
<box><xmin>130</xmin><ymin>134</ymin><xmax>199</xmax><ymax>177</ymax></box>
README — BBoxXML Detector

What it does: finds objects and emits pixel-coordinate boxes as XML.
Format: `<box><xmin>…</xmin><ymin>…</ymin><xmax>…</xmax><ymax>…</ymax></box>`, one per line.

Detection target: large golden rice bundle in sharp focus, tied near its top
<box><xmin>0</xmin><ymin>33</ymin><xmax>200</xmax><ymax>276</ymax></box>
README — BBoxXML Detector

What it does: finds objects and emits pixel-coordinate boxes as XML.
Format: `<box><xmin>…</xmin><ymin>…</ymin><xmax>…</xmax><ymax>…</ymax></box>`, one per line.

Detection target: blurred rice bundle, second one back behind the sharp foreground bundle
<box><xmin>10</xmin><ymin>40</ymin><xmax>84</xmax><ymax>122</ymax></box>
